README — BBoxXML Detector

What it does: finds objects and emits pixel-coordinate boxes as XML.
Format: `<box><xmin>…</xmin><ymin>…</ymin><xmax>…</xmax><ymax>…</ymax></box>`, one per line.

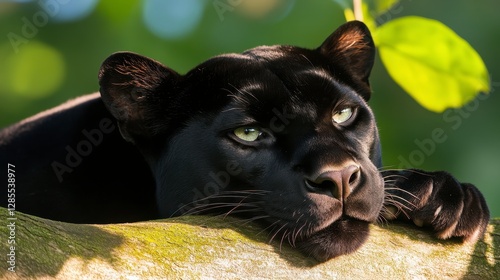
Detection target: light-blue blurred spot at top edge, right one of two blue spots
<box><xmin>143</xmin><ymin>0</ymin><xmax>206</xmax><ymax>39</ymax></box>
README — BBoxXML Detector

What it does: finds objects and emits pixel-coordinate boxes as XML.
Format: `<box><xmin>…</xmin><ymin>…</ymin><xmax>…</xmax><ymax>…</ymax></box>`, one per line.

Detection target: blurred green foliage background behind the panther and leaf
<box><xmin>0</xmin><ymin>0</ymin><xmax>500</xmax><ymax>217</ymax></box>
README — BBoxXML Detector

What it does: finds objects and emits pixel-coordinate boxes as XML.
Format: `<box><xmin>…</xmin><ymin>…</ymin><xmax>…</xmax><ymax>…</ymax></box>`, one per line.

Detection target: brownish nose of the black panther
<box><xmin>306</xmin><ymin>164</ymin><xmax>361</xmax><ymax>201</ymax></box>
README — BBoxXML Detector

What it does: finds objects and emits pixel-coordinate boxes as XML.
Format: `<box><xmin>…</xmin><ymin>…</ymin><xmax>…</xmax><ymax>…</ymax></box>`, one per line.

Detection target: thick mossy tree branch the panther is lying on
<box><xmin>0</xmin><ymin>208</ymin><xmax>500</xmax><ymax>279</ymax></box>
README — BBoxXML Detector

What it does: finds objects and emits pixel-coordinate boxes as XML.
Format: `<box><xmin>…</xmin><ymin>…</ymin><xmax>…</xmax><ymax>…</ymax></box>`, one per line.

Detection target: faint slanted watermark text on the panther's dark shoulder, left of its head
<box><xmin>51</xmin><ymin>118</ymin><xmax>116</xmax><ymax>183</ymax></box>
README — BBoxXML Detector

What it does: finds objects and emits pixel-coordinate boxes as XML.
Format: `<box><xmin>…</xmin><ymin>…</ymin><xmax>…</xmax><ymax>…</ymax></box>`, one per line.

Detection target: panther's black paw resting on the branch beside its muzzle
<box><xmin>382</xmin><ymin>169</ymin><xmax>489</xmax><ymax>242</ymax></box>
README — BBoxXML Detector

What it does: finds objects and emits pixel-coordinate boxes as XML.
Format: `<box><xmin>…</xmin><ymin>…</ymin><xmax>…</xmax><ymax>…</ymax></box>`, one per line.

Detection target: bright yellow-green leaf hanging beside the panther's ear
<box><xmin>374</xmin><ymin>16</ymin><xmax>490</xmax><ymax>112</ymax></box>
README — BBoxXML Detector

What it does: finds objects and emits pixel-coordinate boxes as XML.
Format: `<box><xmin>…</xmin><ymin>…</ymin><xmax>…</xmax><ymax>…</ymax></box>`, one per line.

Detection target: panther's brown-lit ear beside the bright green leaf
<box><xmin>319</xmin><ymin>21</ymin><xmax>375</xmax><ymax>99</ymax></box>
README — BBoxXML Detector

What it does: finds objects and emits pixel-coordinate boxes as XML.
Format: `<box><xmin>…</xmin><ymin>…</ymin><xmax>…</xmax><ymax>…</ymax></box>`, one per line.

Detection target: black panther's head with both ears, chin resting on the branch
<box><xmin>99</xmin><ymin>21</ymin><xmax>384</xmax><ymax>260</ymax></box>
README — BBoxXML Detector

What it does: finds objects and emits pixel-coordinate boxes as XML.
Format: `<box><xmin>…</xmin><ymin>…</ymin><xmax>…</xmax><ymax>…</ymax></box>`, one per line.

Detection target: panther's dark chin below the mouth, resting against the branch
<box><xmin>296</xmin><ymin>218</ymin><xmax>370</xmax><ymax>262</ymax></box>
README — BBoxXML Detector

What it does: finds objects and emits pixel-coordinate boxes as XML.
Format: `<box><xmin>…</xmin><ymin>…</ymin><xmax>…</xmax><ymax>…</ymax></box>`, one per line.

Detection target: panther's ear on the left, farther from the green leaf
<box><xmin>99</xmin><ymin>52</ymin><xmax>179</xmax><ymax>143</ymax></box>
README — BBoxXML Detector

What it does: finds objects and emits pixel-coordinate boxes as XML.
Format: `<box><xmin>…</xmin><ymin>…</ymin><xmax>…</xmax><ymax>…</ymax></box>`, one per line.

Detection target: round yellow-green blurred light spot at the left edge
<box><xmin>0</xmin><ymin>41</ymin><xmax>66</xmax><ymax>99</ymax></box>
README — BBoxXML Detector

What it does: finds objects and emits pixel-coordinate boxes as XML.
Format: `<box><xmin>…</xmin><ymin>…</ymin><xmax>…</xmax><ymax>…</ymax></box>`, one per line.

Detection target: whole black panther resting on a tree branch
<box><xmin>0</xmin><ymin>21</ymin><xmax>489</xmax><ymax>261</ymax></box>
